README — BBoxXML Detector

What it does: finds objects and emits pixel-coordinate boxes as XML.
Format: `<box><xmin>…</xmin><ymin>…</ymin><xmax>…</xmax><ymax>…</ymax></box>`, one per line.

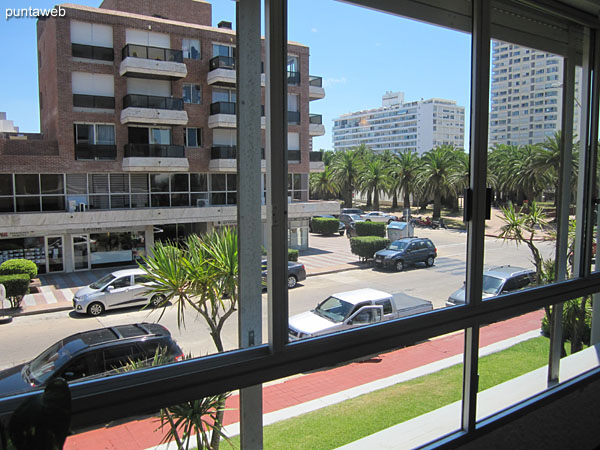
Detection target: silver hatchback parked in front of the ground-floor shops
<box><xmin>73</xmin><ymin>269</ymin><xmax>165</xmax><ymax>316</ymax></box>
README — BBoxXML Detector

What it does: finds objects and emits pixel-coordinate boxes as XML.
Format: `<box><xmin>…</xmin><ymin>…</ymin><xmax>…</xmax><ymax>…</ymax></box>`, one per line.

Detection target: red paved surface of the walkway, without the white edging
<box><xmin>64</xmin><ymin>311</ymin><xmax>544</xmax><ymax>450</ymax></box>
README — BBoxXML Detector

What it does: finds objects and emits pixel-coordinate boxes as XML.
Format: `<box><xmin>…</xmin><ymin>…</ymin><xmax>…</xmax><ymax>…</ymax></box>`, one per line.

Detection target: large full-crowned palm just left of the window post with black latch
<box><xmin>419</xmin><ymin>145</ymin><xmax>455</xmax><ymax>219</ymax></box>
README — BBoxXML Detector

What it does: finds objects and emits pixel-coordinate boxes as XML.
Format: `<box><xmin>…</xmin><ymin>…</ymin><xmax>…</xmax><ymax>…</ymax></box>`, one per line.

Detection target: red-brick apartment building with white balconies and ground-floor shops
<box><xmin>0</xmin><ymin>0</ymin><xmax>332</xmax><ymax>273</ymax></box>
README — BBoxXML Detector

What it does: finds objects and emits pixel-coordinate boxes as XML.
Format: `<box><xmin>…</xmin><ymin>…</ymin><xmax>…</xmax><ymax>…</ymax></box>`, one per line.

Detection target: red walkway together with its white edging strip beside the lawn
<box><xmin>64</xmin><ymin>311</ymin><xmax>544</xmax><ymax>450</ymax></box>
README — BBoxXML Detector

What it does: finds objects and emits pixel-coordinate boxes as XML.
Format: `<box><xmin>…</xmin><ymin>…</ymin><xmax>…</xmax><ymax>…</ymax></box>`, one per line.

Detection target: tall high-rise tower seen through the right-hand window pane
<box><xmin>489</xmin><ymin>41</ymin><xmax>581</xmax><ymax>146</ymax></box>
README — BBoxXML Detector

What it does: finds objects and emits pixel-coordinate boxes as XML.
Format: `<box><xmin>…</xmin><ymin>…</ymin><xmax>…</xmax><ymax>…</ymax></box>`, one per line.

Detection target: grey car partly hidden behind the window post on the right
<box><xmin>446</xmin><ymin>265</ymin><xmax>535</xmax><ymax>306</ymax></box>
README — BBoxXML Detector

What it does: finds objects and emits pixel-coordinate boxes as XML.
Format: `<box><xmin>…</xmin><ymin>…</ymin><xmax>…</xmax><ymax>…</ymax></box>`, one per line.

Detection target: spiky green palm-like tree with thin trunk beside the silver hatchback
<box><xmin>140</xmin><ymin>227</ymin><xmax>238</xmax><ymax>449</ymax></box>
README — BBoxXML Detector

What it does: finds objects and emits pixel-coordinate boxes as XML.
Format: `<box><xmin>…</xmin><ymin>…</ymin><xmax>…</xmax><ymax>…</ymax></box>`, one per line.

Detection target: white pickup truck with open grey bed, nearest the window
<box><xmin>289</xmin><ymin>289</ymin><xmax>433</xmax><ymax>341</ymax></box>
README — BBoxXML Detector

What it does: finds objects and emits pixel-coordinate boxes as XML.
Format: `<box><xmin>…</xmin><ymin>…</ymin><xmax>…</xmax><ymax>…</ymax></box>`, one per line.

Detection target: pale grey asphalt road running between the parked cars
<box><xmin>0</xmin><ymin>230</ymin><xmax>554</xmax><ymax>369</ymax></box>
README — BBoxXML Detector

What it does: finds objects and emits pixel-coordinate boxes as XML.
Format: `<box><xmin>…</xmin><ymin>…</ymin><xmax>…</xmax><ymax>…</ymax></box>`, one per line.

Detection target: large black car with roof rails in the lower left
<box><xmin>0</xmin><ymin>323</ymin><xmax>184</xmax><ymax>394</ymax></box>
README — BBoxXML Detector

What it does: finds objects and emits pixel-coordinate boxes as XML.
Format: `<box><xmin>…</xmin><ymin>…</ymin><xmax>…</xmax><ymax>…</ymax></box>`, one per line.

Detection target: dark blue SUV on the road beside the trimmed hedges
<box><xmin>375</xmin><ymin>237</ymin><xmax>437</xmax><ymax>272</ymax></box>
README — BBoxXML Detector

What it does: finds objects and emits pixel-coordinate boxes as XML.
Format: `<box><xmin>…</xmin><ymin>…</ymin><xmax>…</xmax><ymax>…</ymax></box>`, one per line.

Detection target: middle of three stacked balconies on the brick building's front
<box><xmin>121</xmin><ymin>94</ymin><xmax>188</xmax><ymax>125</ymax></box>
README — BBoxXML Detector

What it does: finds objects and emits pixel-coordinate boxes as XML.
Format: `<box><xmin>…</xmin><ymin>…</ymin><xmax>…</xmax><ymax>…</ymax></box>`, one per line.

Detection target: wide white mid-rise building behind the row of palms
<box><xmin>333</xmin><ymin>92</ymin><xmax>465</xmax><ymax>154</ymax></box>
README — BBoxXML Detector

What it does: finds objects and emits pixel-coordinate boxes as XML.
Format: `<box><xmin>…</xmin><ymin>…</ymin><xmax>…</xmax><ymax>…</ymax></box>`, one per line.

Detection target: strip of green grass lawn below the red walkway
<box><xmin>223</xmin><ymin>337</ymin><xmax>549</xmax><ymax>450</ymax></box>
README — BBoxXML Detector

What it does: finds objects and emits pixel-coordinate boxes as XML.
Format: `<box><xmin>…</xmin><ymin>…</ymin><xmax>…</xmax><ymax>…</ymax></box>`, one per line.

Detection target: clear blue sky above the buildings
<box><xmin>0</xmin><ymin>0</ymin><xmax>471</xmax><ymax>150</ymax></box>
